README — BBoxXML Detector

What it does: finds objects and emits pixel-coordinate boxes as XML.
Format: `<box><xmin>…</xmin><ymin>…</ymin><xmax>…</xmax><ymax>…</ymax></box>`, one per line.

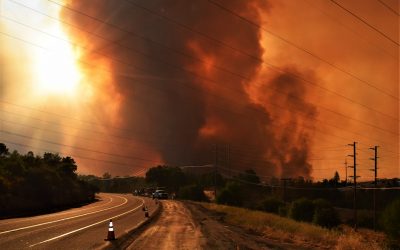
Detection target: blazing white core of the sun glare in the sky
<box><xmin>34</xmin><ymin>8</ymin><xmax>81</xmax><ymax>95</ymax></box>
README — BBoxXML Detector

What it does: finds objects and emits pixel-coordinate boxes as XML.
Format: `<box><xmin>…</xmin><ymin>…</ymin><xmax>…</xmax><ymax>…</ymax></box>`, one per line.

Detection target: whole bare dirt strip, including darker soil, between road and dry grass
<box><xmin>127</xmin><ymin>200</ymin><xmax>301</xmax><ymax>250</ymax></box>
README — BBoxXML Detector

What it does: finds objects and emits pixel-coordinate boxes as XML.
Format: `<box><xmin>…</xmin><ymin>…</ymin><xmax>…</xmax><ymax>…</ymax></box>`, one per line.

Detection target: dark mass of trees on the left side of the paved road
<box><xmin>0</xmin><ymin>143</ymin><xmax>97</xmax><ymax>217</ymax></box>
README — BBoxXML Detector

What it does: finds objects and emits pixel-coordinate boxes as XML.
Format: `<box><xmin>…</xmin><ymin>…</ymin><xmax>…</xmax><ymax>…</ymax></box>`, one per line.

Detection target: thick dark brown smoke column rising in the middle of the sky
<box><xmin>62</xmin><ymin>0</ymin><xmax>316</xmax><ymax>177</ymax></box>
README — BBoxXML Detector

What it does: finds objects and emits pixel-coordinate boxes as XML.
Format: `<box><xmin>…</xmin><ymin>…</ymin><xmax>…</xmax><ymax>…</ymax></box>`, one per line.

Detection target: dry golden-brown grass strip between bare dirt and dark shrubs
<box><xmin>201</xmin><ymin>203</ymin><xmax>385</xmax><ymax>250</ymax></box>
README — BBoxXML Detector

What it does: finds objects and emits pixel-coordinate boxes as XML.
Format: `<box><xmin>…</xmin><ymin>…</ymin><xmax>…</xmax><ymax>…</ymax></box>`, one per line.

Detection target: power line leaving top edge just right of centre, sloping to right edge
<box><xmin>208</xmin><ymin>0</ymin><xmax>399</xmax><ymax>100</ymax></box>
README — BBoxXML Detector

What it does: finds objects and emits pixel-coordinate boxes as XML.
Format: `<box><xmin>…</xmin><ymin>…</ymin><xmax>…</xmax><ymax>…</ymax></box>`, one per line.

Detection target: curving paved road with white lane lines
<box><xmin>0</xmin><ymin>193</ymin><xmax>157</xmax><ymax>250</ymax></box>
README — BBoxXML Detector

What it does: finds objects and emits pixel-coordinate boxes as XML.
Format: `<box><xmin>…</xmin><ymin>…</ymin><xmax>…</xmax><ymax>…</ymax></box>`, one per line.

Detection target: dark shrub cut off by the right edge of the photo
<box><xmin>381</xmin><ymin>199</ymin><xmax>400</xmax><ymax>240</ymax></box>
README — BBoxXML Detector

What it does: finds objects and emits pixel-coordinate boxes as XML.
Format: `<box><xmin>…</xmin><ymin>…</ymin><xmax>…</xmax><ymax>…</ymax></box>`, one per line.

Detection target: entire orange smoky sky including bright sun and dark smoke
<box><xmin>0</xmin><ymin>0</ymin><xmax>400</xmax><ymax>180</ymax></box>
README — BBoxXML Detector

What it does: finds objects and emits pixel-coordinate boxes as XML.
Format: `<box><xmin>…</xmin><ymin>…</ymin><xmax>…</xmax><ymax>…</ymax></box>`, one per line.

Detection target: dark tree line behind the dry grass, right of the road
<box><xmin>79</xmin><ymin>166</ymin><xmax>400</xmax><ymax>243</ymax></box>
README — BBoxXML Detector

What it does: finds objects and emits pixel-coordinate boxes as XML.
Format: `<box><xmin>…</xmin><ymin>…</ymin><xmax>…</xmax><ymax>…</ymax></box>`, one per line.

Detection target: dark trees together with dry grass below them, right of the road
<box><xmin>80</xmin><ymin>166</ymin><xmax>400</xmax><ymax>246</ymax></box>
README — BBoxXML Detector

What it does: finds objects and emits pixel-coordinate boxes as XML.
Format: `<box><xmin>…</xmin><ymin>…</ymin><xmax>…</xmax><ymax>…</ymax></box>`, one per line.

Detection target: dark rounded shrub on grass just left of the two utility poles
<box><xmin>312</xmin><ymin>199</ymin><xmax>340</xmax><ymax>228</ymax></box>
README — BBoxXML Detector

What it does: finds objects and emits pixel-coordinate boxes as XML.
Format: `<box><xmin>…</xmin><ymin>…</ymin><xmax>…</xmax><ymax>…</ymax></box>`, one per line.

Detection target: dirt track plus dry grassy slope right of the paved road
<box><xmin>128</xmin><ymin>200</ymin><xmax>384</xmax><ymax>250</ymax></box>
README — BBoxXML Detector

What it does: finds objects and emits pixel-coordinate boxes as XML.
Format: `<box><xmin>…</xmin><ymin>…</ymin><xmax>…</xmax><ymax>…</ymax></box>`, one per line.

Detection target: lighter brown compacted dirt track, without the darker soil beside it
<box><xmin>127</xmin><ymin>200</ymin><xmax>204</xmax><ymax>250</ymax></box>
